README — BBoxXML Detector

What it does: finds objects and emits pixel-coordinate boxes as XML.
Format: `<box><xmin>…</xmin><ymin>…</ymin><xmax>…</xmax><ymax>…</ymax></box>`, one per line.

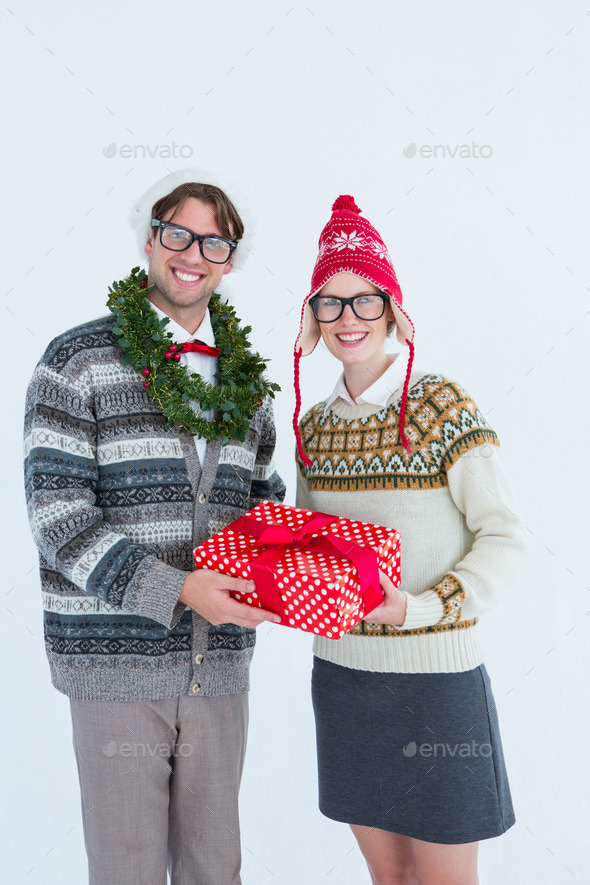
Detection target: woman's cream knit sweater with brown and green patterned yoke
<box><xmin>297</xmin><ymin>372</ymin><xmax>527</xmax><ymax>673</ymax></box>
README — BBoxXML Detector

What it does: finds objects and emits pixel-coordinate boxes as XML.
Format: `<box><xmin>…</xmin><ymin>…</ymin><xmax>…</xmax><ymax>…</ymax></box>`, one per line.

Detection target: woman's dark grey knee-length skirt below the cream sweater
<box><xmin>312</xmin><ymin>658</ymin><xmax>515</xmax><ymax>845</ymax></box>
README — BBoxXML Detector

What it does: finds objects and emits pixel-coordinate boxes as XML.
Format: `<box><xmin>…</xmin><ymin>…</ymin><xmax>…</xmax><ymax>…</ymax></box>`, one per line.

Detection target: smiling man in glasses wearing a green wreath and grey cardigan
<box><xmin>25</xmin><ymin>175</ymin><xmax>285</xmax><ymax>885</ymax></box>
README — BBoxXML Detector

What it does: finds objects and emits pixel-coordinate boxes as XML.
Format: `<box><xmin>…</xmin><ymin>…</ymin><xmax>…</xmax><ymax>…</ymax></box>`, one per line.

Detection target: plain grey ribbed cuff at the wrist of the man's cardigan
<box><xmin>125</xmin><ymin>559</ymin><xmax>190</xmax><ymax>630</ymax></box>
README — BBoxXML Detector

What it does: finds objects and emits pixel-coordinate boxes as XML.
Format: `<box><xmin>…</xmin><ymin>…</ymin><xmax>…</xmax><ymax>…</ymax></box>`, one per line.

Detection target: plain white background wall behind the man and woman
<box><xmin>0</xmin><ymin>0</ymin><xmax>590</xmax><ymax>885</ymax></box>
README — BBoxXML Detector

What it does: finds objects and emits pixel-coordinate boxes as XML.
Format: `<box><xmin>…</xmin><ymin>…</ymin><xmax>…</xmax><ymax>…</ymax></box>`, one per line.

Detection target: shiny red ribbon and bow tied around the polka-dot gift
<box><xmin>232</xmin><ymin>513</ymin><xmax>383</xmax><ymax>617</ymax></box>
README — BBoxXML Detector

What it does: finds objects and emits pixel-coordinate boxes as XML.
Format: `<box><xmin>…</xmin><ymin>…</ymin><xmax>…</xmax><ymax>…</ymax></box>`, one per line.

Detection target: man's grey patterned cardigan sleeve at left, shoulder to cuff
<box><xmin>24</xmin><ymin>360</ymin><xmax>188</xmax><ymax>628</ymax></box>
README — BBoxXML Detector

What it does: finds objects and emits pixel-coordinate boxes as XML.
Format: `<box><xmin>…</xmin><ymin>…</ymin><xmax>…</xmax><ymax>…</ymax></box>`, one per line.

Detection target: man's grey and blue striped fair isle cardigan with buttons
<box><xmin>25</xmin><ymin>317</ymin><xmax>285</xmax><ymax>701</ymax></box>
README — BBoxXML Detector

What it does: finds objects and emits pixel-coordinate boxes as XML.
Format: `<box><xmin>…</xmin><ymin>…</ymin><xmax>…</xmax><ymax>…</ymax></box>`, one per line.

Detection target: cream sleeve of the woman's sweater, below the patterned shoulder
<box><xmin>401</xmin><ymin>430</ymin><xmax>528</xmax><ymax>630</ymax></box>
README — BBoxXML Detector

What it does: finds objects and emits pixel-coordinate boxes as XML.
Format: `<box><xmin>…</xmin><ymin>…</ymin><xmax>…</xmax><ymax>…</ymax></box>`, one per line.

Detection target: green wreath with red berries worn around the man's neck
<box><xmin>107</xmin><ymin>267</ymin><xmax>280</xmax><ymax>443</ymax></box>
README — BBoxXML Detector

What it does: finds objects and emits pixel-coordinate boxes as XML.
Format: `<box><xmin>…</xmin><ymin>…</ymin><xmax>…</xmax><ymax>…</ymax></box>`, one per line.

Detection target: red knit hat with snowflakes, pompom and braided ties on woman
<box><xmin>293</xmin><ymin>196</ymin><xmax>414</xmax><ymax>465</ymax></box>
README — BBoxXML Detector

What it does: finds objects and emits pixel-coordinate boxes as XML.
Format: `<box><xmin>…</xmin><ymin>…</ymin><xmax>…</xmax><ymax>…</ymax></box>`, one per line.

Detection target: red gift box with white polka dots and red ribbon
<box><xmin>194</xmin><ymin>501</ymin><xmax>400</xmax><ymax>639</ymax></box>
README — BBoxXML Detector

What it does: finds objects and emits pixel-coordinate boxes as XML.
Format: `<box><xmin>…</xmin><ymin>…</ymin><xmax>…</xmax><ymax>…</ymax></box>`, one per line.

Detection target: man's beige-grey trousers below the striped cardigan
<box><xmin>71</xmin><ymin>693</ymin><xmax>248</xmax><ymax>885</ymax></box>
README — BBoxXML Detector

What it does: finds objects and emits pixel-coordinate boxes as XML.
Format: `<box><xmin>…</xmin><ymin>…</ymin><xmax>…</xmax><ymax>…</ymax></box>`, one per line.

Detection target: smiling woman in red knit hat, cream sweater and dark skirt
<box><xmin>294</xmin><ymin>196</ymin><xmax>526</xmax><ymax>885</ymax></box>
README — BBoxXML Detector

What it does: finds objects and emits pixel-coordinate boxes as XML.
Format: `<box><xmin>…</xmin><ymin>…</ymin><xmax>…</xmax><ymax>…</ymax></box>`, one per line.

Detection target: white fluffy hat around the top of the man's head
<box><xmin>129</xmin><ymin>166</ymin><xmax>253</xmax><ymax>270</ymax></box>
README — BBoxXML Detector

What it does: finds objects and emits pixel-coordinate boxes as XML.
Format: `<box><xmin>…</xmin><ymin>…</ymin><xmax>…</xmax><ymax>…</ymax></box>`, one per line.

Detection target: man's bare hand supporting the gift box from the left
<box><xmin>178</xmin><ymin>569</ymin><xmax>281</xmax><ymax>627</ymax></box>
